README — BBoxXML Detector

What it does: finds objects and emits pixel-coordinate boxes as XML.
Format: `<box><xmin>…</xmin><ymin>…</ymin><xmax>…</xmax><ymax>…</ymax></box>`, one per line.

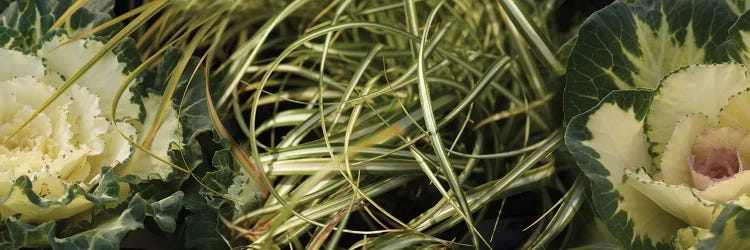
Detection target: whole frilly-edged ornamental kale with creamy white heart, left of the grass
<box><xmin>0</xmin><ymin>0</ymin><xmax>201</xmax><ymax>249</ymax></box>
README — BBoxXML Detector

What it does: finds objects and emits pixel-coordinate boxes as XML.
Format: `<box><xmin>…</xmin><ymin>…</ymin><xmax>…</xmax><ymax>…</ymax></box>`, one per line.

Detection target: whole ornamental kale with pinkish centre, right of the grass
<box><xmin>564</xmin><ymin>1</ymin><xmax>750</xmax><ymax>249</ymax></box>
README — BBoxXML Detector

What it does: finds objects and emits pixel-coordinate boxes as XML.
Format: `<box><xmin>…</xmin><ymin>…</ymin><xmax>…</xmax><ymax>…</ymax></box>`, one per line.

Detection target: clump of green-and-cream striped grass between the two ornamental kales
<box><xmin>132</xmin><ymin>0</ymin><xmax>583</xmax><ymax>249</ymax></box>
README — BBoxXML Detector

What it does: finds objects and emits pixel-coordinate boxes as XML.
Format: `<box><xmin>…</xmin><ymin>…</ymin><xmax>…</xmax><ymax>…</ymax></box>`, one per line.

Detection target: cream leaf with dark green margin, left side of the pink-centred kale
<box><xmin>565</xmin><ymin>89</ymin><xmax>685</xmax><ymax>249</ymax></box>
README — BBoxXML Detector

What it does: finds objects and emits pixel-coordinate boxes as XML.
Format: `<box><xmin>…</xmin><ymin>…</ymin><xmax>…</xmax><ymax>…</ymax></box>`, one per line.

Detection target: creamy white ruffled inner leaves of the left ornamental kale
<box><xmin>0</xmin><ymin>35</ymin><xmax>182</xmax><ymax>222</ymax></box>
